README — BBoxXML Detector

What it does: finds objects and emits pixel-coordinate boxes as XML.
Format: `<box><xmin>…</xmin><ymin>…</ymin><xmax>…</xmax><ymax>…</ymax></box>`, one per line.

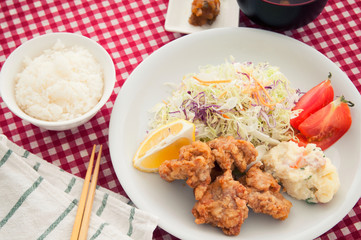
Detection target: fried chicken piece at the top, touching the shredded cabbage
<box><xmin>208</xmin><ymin>136</ymin><xmax>258</xmax><ymax>172</ymax></box>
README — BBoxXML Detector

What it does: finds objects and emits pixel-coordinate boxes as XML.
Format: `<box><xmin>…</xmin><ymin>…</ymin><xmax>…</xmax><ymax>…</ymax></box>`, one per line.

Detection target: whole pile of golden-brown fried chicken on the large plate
<box><xmin>159</xmin><ymin>136</ymin><xmax>292</xmax><ymax>236</ymax></box>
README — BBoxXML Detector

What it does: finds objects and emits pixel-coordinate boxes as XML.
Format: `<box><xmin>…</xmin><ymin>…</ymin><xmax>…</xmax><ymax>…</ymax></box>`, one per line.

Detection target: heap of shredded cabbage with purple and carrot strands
<box><xmin>150</xmin><ymin>58</ymin><xmax>300</xmax><ymax>147</ymax></box>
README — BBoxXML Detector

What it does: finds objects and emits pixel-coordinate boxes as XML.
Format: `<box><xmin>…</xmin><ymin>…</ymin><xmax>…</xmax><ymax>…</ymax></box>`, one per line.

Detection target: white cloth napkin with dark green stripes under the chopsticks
<box><xmin>0</xmin><ymin>134</ymin><xmax>158</xmax><ymax>240</ymax></box>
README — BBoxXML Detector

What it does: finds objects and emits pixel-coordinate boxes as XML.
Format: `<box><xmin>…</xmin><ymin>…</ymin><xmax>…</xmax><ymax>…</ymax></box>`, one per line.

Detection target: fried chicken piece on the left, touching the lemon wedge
<box><xmin>159</xmin><ymin>141</ymin><xmax>214</xmax><ymax>200</ymax></box>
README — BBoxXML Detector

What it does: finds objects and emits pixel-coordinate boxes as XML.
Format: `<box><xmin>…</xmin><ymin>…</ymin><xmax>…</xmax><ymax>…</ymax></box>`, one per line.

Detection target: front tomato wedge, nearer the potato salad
<box><xmin>298</xmin><ymin>97</ymin><xmax>352</xmax><ymax>150</ymax></box>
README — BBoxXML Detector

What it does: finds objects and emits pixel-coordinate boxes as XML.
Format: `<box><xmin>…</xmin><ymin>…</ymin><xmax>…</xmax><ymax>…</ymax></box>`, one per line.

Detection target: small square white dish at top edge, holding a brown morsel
<box><xmin>164</xmin><ymin>0</ymin><xmax>240</xmax><ymax>33</ymax></box>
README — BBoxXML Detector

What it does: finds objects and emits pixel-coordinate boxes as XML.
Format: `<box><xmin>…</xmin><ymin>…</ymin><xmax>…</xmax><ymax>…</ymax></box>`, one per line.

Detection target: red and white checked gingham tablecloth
<box><xmin>0</xmin><ymin>0</ymin><xmax>361</xmax><ymax>240</ymax></box>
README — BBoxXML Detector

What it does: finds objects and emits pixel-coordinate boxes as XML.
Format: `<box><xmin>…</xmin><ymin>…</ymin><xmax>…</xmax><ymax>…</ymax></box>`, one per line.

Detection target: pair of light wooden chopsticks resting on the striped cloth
<box><xmin>71</xmin><ymin>145</ymin><xmax>103</xmax><ymax>240</ymax></box>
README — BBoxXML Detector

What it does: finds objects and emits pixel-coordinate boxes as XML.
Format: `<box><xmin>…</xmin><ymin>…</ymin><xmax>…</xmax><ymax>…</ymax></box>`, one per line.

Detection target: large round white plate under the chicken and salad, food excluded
<box><xmin>109</xmin><ymin>28</ymin><xmax>361</xmax><ymax>240</ymax></box>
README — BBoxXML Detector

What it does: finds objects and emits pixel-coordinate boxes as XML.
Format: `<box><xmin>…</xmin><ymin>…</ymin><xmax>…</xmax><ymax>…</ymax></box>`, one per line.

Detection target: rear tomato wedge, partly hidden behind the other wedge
<box><xmin>290</xmin><ymin>79</ymin><xmax>334</xmax><ymax>129</ymax></box>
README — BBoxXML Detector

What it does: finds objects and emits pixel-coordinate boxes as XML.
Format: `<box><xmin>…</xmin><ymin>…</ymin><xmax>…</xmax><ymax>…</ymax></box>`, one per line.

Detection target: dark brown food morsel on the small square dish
<box><xmin>188</xmin><ymin>0</ymin><xmax>221</xmax><ymax>26</ymax></box>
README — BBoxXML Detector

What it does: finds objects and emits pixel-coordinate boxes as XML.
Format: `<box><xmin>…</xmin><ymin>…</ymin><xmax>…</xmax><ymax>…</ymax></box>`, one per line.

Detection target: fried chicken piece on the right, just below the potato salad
<box><xmin>242</xmin><ymin>163</ymin><xmax>292</xmax><ymax>220</ymax></box>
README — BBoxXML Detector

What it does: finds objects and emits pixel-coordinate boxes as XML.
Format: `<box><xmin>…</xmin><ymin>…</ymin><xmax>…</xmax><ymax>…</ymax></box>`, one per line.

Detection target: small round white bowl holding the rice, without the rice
<box><xmin>0</xmin><ymin>32</ymin><xmax>116</xmax><ymax>131</ymax></box>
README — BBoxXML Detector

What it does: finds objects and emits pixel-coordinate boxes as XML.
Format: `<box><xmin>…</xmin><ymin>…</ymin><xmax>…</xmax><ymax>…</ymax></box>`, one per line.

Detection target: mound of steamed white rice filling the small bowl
<box><xmin>15</xmin><ymin>40</ymin><xmax>104</xmax><ymax>121</ymax></box>
